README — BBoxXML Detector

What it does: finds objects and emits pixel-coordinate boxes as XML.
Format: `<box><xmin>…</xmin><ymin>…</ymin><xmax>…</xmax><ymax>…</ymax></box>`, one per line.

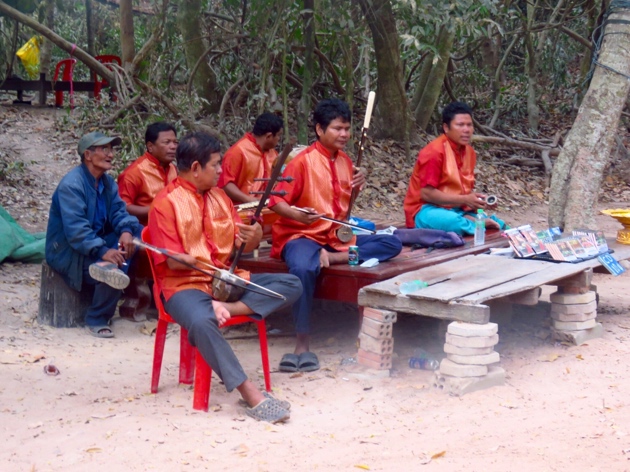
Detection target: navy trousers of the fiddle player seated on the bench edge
<box><xmin>282</xmin><ymin>234</ymin><xmax>402</xmax><ymax>334</ymax></box>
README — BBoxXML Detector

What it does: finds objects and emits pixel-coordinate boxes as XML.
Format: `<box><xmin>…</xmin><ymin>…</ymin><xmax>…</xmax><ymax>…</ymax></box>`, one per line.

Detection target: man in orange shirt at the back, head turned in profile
<box><xmin>219</xmin><ymin>113</ymin><xmax>283</xmax><ymax>203</ymax></box>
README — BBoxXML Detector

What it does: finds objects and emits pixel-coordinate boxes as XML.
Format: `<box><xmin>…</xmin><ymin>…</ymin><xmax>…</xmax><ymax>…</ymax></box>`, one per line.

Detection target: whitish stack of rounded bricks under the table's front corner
<box><xmin>440</xmin><ymin>321</ymin><xmax>500</xmax><ymax>377</ymax></box>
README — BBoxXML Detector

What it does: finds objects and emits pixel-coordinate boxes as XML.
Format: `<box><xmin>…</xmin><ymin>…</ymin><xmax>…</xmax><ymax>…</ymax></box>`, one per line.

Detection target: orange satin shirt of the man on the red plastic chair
<box><xmin>149</xmin><ymin>177</ymin><xmax>249</xmax><ymax>300</ymax></box>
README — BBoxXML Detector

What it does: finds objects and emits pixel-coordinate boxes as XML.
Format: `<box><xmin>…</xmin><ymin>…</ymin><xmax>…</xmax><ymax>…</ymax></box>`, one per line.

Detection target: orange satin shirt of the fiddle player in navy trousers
<box><xmin>269</xmin><ymin>141</ymin><xmax>356</xmax><ymax>258</ymax></box>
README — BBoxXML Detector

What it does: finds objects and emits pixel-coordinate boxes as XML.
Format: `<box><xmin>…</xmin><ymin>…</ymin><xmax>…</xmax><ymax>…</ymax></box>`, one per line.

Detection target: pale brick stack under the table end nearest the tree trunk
<box><xmin>550</xmin><ymin>287</ymin><xmax>603</xmax><ymax>345</ymax></box>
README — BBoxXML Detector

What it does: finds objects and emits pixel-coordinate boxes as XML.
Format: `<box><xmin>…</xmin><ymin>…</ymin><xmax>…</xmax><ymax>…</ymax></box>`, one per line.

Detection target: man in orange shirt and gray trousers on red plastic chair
<box><xmin>149</xmin><ymin>133</ymin><xmax>302</xmax><ymax>423</ymax></box>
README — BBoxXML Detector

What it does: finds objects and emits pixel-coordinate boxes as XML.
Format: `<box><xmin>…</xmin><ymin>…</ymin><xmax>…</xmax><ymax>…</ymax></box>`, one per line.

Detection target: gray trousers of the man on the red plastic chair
<box><xmin>165</xmin><ymin>274</ymin><xmax>302</xmax><ymax>392</ymax></box>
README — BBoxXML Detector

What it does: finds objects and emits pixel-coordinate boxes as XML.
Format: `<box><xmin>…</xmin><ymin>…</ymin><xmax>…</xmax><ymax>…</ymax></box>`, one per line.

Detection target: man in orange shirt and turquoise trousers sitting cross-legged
<box><xmin>404</xmin><ymin>102</ymin><xmax>505</xmax><ymax>235</ymax></box>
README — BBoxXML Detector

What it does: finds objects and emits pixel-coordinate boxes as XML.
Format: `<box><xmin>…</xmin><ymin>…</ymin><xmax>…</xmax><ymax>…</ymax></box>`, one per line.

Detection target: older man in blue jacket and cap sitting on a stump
<box><xmin>46</xmin><ymin>131</ymin><xmax>142</xmax><ymax>338</ymax></box>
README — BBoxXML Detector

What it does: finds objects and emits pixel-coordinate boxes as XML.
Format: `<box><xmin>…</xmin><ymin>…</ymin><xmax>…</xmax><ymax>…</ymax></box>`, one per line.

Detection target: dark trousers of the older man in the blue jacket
<box><xmin>83</xmin><ymin>233</ymin><xmax>135</xmax><ymax>326</ymax></box>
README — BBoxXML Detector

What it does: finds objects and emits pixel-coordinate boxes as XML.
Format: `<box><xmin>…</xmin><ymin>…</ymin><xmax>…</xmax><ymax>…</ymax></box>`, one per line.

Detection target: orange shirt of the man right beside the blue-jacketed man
<box><xmin>118</xmin><ymin>151</ymin><xmax>177</xmax><ymax>207</ymax></box>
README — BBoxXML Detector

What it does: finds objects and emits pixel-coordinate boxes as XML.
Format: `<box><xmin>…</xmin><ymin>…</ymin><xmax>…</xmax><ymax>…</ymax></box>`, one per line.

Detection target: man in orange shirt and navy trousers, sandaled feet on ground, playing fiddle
<box><xmin>269</xmin><ymin>99</ymin><xmax>402</xmax><ymax>372</ymax></box>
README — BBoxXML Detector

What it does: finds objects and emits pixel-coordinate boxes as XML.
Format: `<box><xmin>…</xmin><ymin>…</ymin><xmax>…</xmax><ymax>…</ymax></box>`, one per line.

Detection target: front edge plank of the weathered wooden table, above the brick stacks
<box><xmin>359</xmin><ymin>289</ymin><xmax>490</xmax><ymax>324</ymax></box>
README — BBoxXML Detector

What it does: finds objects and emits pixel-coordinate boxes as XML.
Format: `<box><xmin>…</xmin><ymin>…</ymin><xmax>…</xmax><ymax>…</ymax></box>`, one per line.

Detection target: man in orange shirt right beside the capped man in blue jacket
<box><xmin>118</xmin><ymin>121</ymin><xmax>177</xmax><ymax>226</ymax></box>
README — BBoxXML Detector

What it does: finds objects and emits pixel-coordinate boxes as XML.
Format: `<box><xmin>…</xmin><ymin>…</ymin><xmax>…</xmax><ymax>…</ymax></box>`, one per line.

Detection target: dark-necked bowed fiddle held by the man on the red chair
<box><xmin>212</xmin><ymin>143</ymin><xmax>293</xmax><ymax>302</ymax></box>
